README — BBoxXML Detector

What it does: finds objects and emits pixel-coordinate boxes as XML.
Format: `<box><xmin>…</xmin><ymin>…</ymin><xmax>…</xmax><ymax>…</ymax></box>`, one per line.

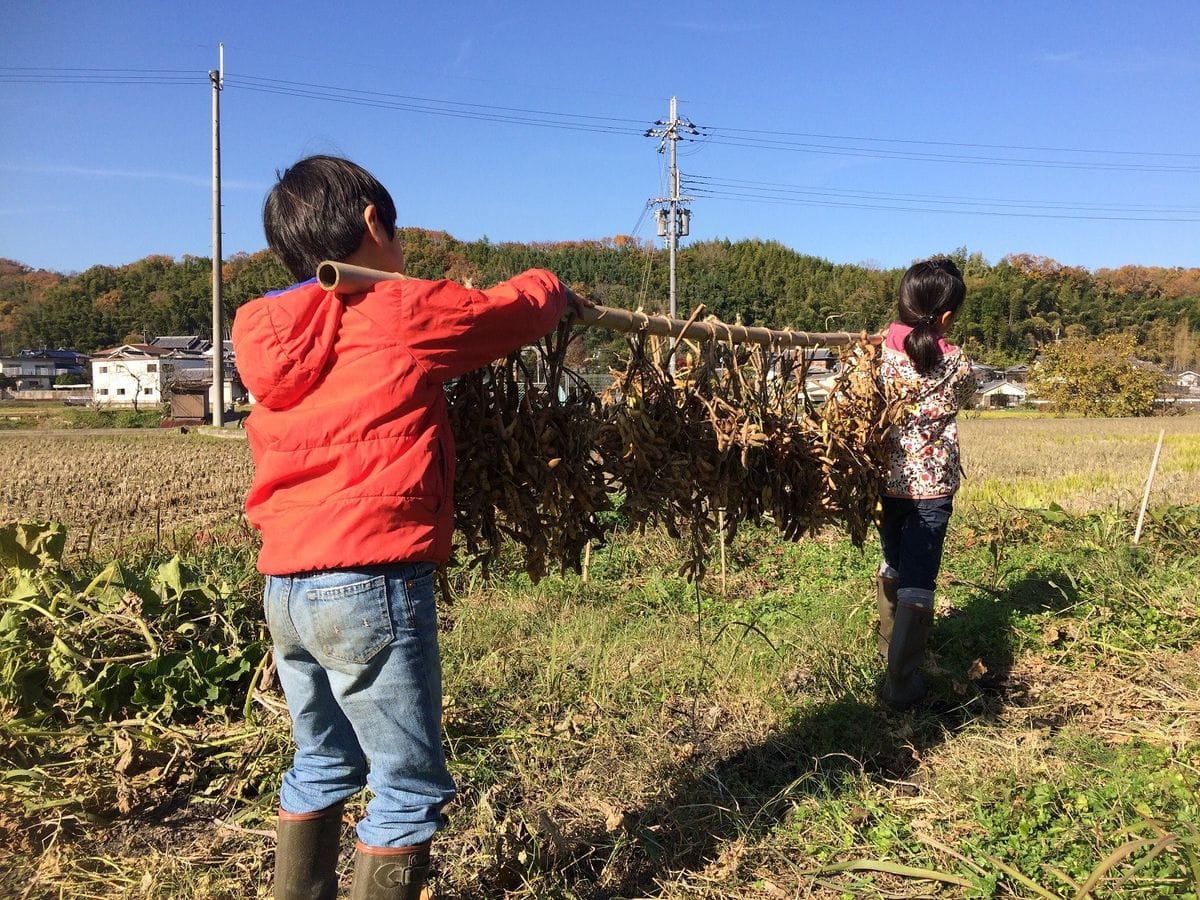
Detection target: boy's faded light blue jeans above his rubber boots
<box><xmin>265</xmin><ymin>563</ymin><xmax>455</xmax><ymax>847</ymax></box>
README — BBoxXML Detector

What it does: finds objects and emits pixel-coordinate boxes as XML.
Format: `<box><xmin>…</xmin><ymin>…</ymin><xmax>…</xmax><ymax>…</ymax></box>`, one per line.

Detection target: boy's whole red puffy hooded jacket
<box><xmin>233</xmin><ymin>269</ymin><xmax>566</xmax><ymax>575</ymax></box>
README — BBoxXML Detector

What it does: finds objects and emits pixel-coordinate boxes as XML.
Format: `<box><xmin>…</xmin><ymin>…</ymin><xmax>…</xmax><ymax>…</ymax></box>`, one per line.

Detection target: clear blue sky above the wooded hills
<box><xmin>0</xmin><ymin>0</ymin><xmax>1200</xmax><ymax>271</ymax></box>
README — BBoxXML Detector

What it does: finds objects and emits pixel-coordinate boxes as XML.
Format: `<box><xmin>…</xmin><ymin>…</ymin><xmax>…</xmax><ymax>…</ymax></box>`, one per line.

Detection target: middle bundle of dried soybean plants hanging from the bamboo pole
<box><xmin>598</xmin><ymin>311</ymin><xmax>824</xmax><ymax>577</ymax></box>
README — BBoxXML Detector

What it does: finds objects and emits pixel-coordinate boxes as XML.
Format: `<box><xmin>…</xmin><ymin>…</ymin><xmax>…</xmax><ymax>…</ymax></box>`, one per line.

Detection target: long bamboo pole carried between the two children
<box><xmin>317</xmin><ymin>260</ymin><xmax>882</xmax><ymax>347</ymax></box>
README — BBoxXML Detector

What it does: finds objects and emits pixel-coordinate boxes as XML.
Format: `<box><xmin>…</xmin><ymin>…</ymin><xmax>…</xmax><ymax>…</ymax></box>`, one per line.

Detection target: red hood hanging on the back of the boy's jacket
<box><xmin>233</xmin><ymin>281</ymin><xmax>344</xmax><ymax>409</ymax></box>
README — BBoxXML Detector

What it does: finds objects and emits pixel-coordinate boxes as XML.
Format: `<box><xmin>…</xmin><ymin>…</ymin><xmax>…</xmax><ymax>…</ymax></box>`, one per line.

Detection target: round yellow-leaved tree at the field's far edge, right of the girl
<box><xmin>1031</xmin><ymin>335</ymin><xmax>1163</xmax><ymax>416</ymax></box>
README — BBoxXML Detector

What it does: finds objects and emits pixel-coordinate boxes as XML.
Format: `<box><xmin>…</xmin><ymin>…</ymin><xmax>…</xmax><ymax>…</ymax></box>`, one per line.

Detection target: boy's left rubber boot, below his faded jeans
<box><xmin>275</xmin><ymin>803</ymin><xmax>343</xmax><ymax>900</ymax></box>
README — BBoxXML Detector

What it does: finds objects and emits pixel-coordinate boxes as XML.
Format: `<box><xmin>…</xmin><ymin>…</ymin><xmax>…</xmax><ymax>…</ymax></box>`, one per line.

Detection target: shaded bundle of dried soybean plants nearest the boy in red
<box><xmin>449</xmin><ymin>324</ymin><xmax>611</xmax><ymax>581</ymax></box>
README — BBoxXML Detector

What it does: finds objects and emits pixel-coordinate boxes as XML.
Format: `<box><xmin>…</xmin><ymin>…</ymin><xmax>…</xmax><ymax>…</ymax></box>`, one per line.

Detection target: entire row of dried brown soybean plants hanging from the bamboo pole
<box><xmin>450</xmin><ymin>310</ymin><xmax>896</xmax><ymax>580</ymax></box>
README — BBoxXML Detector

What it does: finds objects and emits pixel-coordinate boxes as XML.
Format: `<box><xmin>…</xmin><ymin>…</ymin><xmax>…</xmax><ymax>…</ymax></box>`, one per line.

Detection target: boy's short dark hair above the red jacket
<box><xmin>263</xmin><ymin>156</ymin><xmax>396</xmax><ymax>281</ymax></box>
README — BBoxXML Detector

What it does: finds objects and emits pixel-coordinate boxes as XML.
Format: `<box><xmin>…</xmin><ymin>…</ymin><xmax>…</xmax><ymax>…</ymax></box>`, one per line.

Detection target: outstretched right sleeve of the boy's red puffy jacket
<box><xmin>398</xmin><ymin>269</ymin><xmax>566</xmax><ymax>382</ymax></box>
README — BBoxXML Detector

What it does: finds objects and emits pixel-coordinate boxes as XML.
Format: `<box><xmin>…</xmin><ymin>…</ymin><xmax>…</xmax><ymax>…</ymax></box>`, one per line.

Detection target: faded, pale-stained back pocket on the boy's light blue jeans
<box><xmin>305</xmin><ymin>575</ymin><xmax>396</xmax><ymax>662</ymax></box>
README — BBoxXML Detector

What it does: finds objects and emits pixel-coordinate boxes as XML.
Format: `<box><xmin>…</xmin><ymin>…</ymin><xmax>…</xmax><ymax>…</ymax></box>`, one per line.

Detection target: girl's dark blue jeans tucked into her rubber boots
<box><xmin>880</xmin><ymin>497</ymin><xmax>954</xmax><ymax>610</ymax></box>
